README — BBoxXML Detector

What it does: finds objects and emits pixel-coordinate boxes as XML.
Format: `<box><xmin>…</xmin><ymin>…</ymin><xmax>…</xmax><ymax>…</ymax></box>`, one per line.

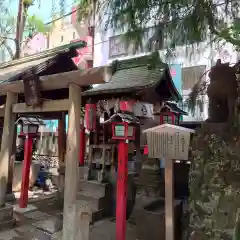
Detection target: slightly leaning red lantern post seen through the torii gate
<box><xmin>19</xmin><ymin>135</ymin><xmax>33</xmax><ymax>208</ymax></box>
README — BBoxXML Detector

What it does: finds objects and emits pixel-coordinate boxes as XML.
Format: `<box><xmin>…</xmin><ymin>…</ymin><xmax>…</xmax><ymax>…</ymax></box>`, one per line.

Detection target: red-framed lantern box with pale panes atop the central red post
<box><xmin>112</xmin><ymin>122</ymin><xmax>136</xmax><ymax>140</ymax></box>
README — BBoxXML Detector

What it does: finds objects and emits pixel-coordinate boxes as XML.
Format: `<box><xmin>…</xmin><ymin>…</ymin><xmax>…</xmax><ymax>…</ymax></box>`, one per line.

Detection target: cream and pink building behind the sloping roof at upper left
<box><xmin>23</xmin><ymin>8</ymin><xmax>93</xmax><ymax>68</ymax></box>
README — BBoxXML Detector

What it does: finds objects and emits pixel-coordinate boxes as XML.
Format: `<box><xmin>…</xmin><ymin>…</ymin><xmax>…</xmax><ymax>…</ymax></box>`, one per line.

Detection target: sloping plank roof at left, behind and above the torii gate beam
<box><xmin>0</xmin><ymin>41</ymin><xmax>86</xmax><ymax>84</ymax></box>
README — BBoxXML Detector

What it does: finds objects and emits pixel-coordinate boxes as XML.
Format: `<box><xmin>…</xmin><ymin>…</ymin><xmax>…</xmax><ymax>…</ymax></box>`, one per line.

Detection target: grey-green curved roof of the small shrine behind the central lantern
<box><xmin>84</xmin><ymin>54</ymin><xmax>181</xmax><ymax>100</ymax></box>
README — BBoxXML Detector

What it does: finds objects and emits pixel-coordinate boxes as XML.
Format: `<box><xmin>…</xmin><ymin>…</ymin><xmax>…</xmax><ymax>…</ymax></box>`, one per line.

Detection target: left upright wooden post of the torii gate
<box><xmin>0</xmin><ymin>92</ymin><xmax>18</xmax><ymax>206</ymax></box>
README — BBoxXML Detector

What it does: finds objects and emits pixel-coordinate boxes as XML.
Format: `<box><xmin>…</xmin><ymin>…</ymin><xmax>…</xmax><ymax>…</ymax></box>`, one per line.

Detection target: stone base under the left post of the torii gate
<box><xmin>0</xmin><ymin>204</ymin><xmax>15</xmax><ymax>231</ymax></box>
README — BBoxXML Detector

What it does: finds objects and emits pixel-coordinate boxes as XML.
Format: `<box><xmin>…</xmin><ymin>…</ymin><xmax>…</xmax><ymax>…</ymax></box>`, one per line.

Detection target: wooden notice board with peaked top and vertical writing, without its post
<box><xmin>144</xmin><ymin>124</ymin><xmax>195</xmax><ymax>160</ymax></box>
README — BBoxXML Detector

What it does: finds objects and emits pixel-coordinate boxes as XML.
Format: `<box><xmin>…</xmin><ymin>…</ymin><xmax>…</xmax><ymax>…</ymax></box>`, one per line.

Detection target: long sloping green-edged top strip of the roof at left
<box><xmin>0</xmin><ymin>40</ymin><xmax>87</xmax><ymax>70</ymax></box>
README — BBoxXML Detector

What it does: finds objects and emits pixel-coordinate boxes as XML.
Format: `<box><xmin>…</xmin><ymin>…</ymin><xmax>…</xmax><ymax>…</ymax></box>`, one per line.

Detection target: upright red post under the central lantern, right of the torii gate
<box><xmin>116</xmin><ymin>140</ymin><xmax>128</xmax><ymax>240</ymax></box>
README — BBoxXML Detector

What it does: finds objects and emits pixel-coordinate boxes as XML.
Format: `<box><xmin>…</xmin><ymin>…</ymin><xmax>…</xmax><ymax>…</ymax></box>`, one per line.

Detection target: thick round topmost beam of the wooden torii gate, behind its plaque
<box><xmin>0</xmin><ymin>66</ymin><xmax>111</xmax><ymax>96</ymax></box>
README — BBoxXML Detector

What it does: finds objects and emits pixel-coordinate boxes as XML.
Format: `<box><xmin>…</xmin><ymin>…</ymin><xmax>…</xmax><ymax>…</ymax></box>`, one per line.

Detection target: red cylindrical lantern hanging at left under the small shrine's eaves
<box><xmin>85</xmin><ymin>103</ymin><xmax>97</xmax><ymax>132</ymax></box>
